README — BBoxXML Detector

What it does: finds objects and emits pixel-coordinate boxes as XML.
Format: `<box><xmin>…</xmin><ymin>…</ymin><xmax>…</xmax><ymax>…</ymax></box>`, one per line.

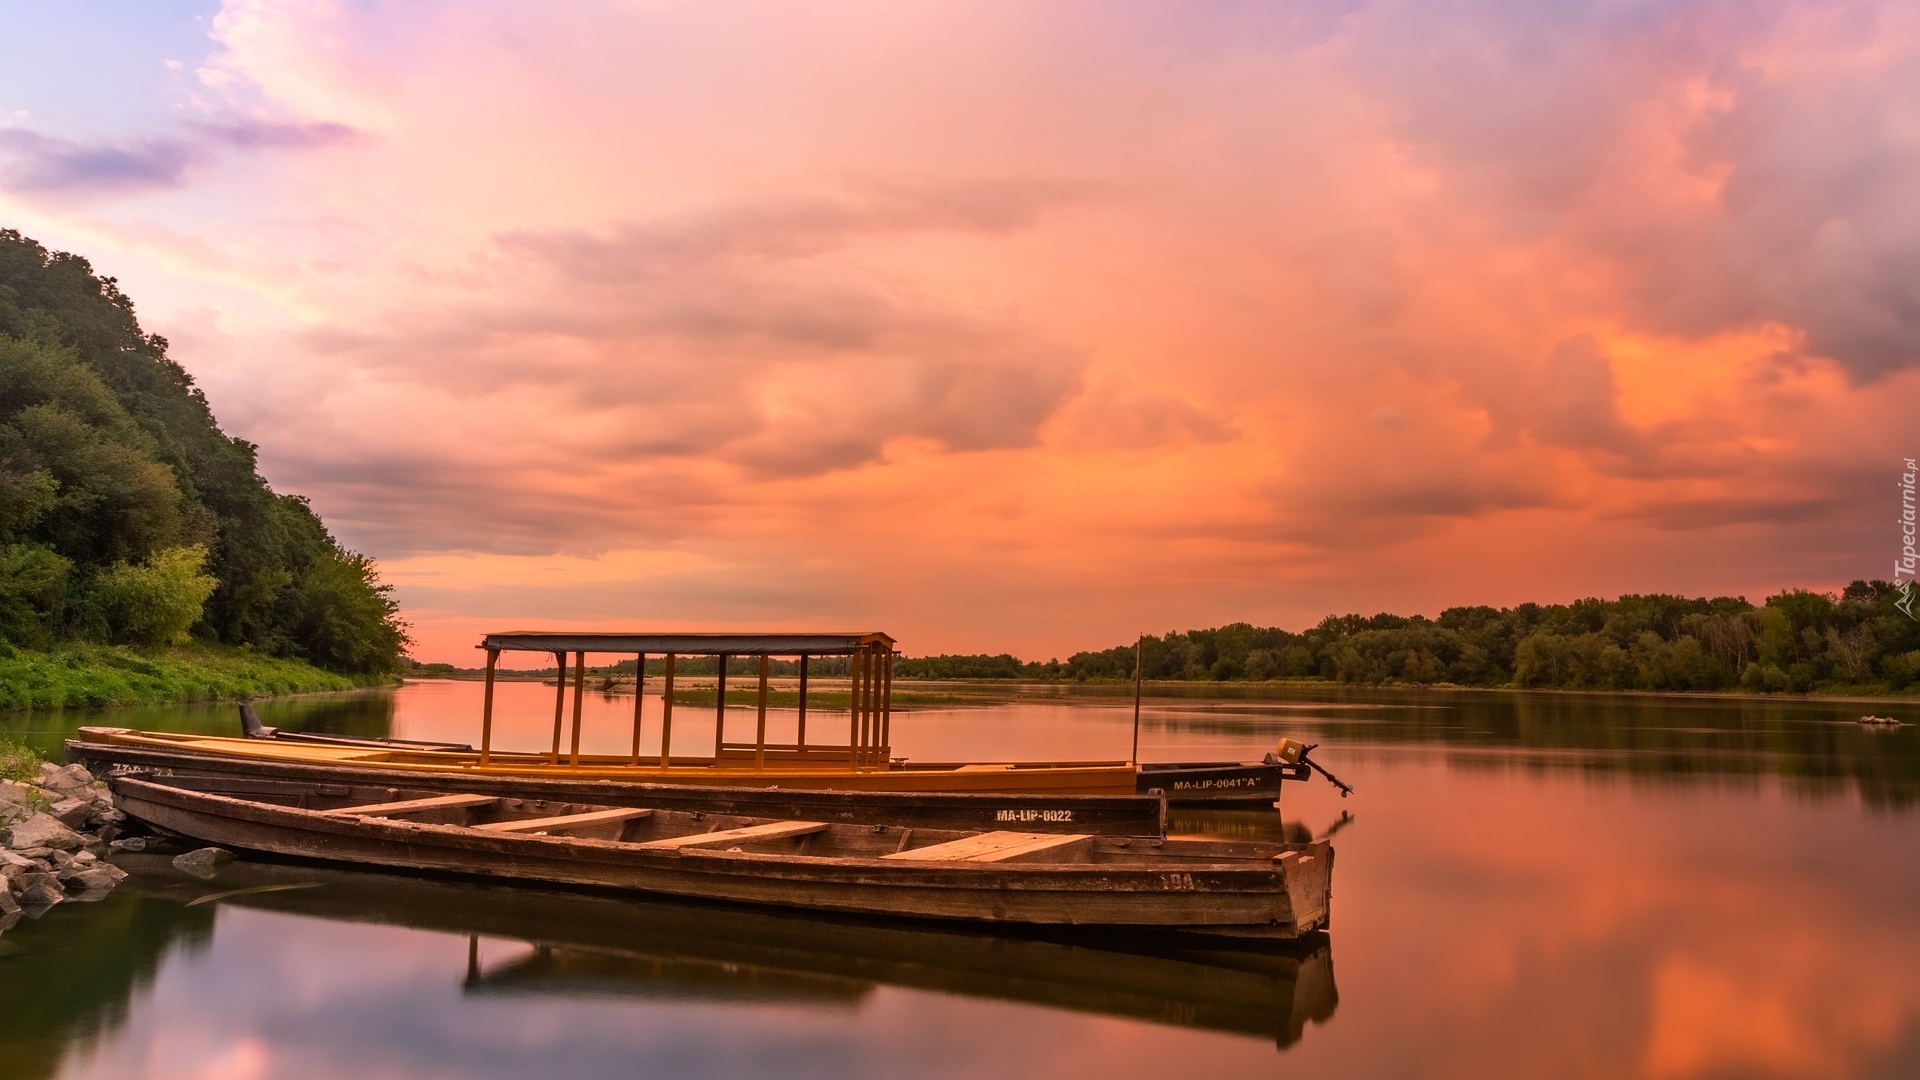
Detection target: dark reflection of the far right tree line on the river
<box><xmin>1156</xmin><ymin>686</ymin><xmax>1920</xmax><ymax>805</ymax></box>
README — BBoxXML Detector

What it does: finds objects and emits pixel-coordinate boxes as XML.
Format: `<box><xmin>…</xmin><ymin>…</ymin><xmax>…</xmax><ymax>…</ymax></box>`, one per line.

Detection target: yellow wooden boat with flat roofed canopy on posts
<box><xmin>67</xmin><ymin>632</ymin><xmax>1311</xmax><ymax>803</ymax></box>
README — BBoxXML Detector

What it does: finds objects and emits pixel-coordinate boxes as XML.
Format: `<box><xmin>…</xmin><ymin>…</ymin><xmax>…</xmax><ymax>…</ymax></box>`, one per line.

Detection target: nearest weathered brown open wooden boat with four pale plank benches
<box><xmin>111</xmin><ymin>773</ymin><xmax>1332</xmax><ymax>942</ymax></box>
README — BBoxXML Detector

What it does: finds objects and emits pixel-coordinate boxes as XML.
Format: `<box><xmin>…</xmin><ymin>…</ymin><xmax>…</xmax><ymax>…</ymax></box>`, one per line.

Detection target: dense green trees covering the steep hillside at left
<box><xmin>0</xmin><ymin>231</ymin><xmax>407</xmax><ymax>675</ymax></box>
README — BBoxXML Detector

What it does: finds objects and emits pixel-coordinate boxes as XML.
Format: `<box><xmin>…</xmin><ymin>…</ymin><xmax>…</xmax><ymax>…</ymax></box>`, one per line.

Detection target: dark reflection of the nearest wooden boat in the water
<box><xmin>123</xmin><ymin>857</ymin><xmax>1338</xmax><ymax>1045</ymax></box>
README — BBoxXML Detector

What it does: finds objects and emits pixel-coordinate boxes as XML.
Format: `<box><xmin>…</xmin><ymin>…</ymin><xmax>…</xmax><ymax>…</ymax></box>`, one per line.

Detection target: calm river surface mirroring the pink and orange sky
<box><xmin>0</xmin><ymin>682</ymin><xmax>1920</xmax><ymax>1080</ymax></box>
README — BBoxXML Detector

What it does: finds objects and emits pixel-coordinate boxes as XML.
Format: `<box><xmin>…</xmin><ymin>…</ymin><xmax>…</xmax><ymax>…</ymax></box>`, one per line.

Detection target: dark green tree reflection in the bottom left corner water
<box><xmin>0</xmin><ymin>886</ymin><xmax>213</xmax><ymax>1080</ymax></box>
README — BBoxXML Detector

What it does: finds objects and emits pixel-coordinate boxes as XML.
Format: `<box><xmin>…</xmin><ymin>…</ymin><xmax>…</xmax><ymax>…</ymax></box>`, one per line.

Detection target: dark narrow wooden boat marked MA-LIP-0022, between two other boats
<box><xmin>67</xmin><ymin>726</ymin><xmax>1167</xmax><ymax>836</ymax></box>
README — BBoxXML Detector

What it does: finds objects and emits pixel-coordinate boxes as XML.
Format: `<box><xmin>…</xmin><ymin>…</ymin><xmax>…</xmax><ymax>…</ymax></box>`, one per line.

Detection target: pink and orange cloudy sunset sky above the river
<box><xmin>0</xmin><ymin>0</ymin><xmax>1920</xmax><ymax>663</ymax></box>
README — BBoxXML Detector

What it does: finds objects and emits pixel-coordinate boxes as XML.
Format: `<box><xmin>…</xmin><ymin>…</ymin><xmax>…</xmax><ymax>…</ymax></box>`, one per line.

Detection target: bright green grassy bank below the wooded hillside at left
<box><xmin>0</xmin><ymin>644</ymin><xmax>386</xmax><ymax>709</ymax></box>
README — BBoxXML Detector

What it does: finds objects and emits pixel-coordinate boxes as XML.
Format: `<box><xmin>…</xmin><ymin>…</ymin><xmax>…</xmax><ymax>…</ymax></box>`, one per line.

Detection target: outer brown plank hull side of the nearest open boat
<box><xmin>113</xmin><ymin>776</ymin><xmax>1332</xmax><ymax>940</ymax></box>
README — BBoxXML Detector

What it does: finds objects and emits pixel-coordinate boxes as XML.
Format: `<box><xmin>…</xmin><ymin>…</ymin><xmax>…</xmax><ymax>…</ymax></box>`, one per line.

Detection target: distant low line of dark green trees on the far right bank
<box><xmin>895</xmin><ymin>580</ymin><xmax>1920</xmax><ymax>694</ymax></box>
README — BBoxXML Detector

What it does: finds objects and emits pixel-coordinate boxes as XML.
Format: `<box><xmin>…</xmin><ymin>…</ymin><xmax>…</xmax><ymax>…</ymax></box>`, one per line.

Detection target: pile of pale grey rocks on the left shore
<box><xmin>0</xmin><ymin>765</ymin><xmax>127</xmax><ymax>930</ymax></box>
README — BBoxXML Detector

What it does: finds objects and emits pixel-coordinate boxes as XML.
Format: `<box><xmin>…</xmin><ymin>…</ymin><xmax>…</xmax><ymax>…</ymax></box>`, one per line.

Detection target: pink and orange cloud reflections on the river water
<box><xmin>45</xmin><ymin>722</ymin><xmax>1920</xmax><ymax>1080</ymax></box>
